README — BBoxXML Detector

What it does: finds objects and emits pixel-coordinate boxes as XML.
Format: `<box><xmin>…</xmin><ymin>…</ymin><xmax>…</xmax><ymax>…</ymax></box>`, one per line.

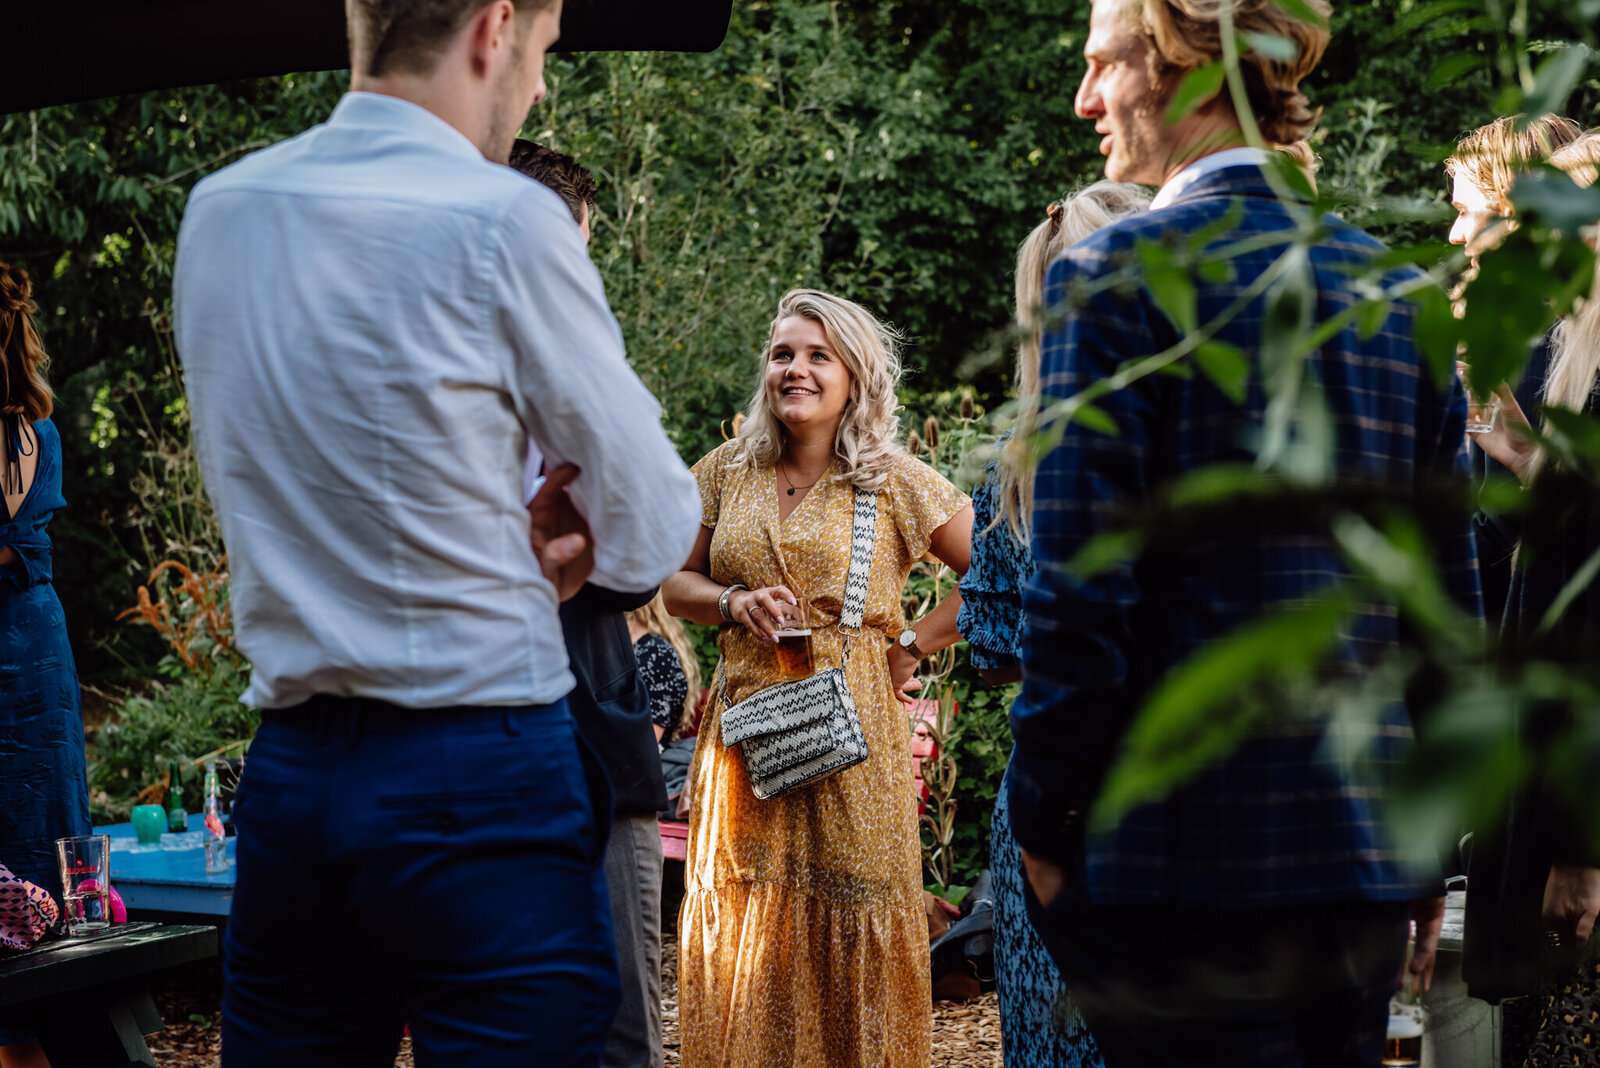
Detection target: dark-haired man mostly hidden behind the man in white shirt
<box><xmin>510</xmin><ymin>137</ymin><xmax>667</xmax><ymax>1068</ymax></box>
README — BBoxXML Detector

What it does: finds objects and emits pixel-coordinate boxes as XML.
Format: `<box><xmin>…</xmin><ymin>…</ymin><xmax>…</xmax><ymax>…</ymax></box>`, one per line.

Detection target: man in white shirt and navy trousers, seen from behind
<box><xmin>174</xmin><ymin>0</ymin><xmax>699</xmax><ymax>1068</ymax></box>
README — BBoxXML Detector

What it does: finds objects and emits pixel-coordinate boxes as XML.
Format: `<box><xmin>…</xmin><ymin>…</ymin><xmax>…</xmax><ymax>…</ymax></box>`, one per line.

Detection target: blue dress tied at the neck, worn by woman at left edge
<box><xmin>0</xmin><ymin>416</ymin><xmax>90</xmax><ymax>920</ymax></box>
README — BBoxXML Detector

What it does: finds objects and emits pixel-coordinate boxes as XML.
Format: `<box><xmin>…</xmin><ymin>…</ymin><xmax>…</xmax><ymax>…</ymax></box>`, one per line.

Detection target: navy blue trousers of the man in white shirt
<box><xmin>222</xmin><ymin>697</ymin><xmax>618</xmax><ymax>1068</ymax></box>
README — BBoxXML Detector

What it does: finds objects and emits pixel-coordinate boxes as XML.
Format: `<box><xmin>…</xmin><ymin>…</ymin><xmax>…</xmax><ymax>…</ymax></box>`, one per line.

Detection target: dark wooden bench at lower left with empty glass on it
<box><xmin>0</xmin><ymin>923</ymin><xmax>216</xmax><ymax>1068</ymax></box>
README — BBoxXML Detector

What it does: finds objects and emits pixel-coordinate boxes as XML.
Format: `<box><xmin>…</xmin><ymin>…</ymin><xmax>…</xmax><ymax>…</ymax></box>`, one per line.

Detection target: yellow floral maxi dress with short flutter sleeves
<box><xmin>678</xmin><ymin>443</ymin><xmax>966</xmax><ymax>1068</ymax></box>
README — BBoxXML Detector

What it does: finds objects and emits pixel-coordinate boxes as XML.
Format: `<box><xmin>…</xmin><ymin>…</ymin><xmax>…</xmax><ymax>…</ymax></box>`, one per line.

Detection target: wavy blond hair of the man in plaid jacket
<box><xmin>1134</xmin><ymin>0</ymin><xmax>1333</xmax><ymax>145</ymax></box>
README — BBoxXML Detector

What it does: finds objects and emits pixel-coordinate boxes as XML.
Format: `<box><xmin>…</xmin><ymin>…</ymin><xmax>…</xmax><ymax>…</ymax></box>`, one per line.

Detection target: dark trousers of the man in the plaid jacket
<box><xmin>1027</xmin><ymin>889</ymin><xmax>1408</xmax><ymax>1068</ymax></box>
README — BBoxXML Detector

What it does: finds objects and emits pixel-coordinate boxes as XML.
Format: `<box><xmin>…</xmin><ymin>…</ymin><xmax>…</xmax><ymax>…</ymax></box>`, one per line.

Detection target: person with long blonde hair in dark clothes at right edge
<box><xmin>1462</xmin><ymin>130</ymin><xmax>1600</xmax><ymax>1066</ymax></box>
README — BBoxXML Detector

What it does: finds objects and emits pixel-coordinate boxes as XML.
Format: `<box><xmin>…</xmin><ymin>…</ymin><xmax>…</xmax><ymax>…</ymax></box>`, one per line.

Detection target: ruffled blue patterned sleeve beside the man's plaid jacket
<box><xmin>955</xmin><ymin>464</ymin><xmax>1034</xmax><ymax>671</ymax></box>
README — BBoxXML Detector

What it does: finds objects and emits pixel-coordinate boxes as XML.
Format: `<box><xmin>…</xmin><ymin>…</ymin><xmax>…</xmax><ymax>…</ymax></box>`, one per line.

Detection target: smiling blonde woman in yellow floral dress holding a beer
<box><xmin>662</xmin><ymin>289</ymin><xmax>973</xmax><ymax>1068</ymax></box>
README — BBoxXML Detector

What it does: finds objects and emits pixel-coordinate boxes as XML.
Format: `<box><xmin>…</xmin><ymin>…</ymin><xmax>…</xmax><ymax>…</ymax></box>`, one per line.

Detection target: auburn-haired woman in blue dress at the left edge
<box><xmin>0</xmin><ymin>264</ymin><xmax>90</xmax><ymax>1068</ymax></box>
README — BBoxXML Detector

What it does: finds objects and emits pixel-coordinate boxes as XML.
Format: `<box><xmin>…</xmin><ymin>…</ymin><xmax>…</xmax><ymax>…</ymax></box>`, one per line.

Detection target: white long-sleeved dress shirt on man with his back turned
<box><xmin>173</xmin><ymin>93</ymin><xmax>699</xmax><ymax>708</ymax></box>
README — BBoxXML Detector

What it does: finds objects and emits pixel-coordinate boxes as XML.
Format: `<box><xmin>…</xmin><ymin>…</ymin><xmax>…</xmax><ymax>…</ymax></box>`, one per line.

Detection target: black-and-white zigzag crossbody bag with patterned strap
<box><xmin>717</xmin><ymin>489</ymin><xmax>878</xmax><ymax>799</ymax></box>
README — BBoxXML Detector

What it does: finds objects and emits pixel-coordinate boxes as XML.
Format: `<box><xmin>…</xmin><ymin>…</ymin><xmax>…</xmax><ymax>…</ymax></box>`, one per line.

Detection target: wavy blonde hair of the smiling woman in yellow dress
<box><xmin>733</xmin><ymin>289</ymin><xmax>906</xmax><ymax>489</ymax></box>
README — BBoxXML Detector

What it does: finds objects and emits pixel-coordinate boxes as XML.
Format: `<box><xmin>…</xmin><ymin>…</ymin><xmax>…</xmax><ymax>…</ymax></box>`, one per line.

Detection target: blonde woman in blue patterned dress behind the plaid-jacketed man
<box><xmin>958</xmin><ymin>182</ymin><xmax>1150</xmax><ymax>1068</ymax></box>
